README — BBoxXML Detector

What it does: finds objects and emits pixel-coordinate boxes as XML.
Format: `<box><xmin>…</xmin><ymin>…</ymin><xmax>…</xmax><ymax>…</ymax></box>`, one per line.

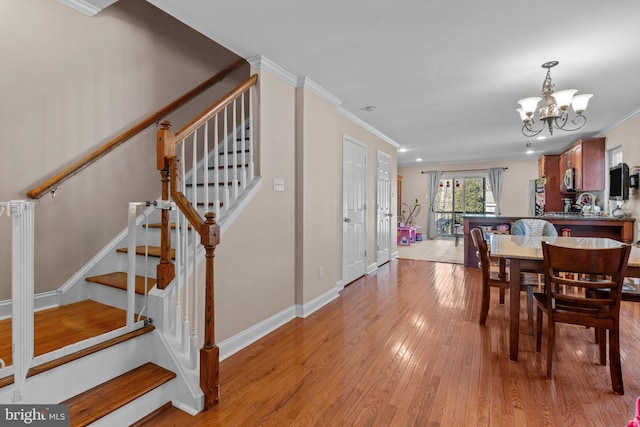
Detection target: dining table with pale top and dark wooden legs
<box><xmin>487</xmin><ymin>234</ymin><xmax>640</xmax><ymax>361</ymax></box>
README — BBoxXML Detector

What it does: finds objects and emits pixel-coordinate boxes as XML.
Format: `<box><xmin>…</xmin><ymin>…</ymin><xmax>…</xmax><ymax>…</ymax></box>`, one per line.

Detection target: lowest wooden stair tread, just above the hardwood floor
<box><xmin>61</xmin><ymin>362</ymin><xmax>176</xmax><ymax>426</ymax></box>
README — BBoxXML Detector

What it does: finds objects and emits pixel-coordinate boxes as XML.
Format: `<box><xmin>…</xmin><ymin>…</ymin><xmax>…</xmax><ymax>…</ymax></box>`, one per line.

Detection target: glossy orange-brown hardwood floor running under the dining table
<box><xmin>148</xmin><ymin>260</ymin><xmax>640</xmax><ymax>427</ymax></box>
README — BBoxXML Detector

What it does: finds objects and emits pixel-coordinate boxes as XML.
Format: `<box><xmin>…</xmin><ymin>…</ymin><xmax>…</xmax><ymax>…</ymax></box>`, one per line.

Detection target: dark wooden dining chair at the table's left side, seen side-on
<box><xmin>471</xmin><ymin>228</ymin><xmax>533</xmax><ymax>330</ymax></box>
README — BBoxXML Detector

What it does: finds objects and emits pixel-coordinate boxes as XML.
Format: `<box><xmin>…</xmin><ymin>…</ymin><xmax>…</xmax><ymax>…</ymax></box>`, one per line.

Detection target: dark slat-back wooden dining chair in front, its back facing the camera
<box><xmin>534</xmin><ymin>242</ymin><xmax>631</xmax><ymax>394</ymax></box>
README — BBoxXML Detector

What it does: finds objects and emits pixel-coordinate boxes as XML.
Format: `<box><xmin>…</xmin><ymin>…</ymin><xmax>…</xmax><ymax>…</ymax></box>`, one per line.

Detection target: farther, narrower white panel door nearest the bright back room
<box><xmin>376</xmin><ymin>151</ymin><xmax>393</xmax><ymax>265</ymax></box>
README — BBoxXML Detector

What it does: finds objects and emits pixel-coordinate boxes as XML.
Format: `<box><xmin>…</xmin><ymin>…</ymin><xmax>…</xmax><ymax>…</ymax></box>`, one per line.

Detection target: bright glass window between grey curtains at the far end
<box><xmin>435</xmin><ymin>176</ymin><xmax>496</xmax><ymax>237</ymax></box>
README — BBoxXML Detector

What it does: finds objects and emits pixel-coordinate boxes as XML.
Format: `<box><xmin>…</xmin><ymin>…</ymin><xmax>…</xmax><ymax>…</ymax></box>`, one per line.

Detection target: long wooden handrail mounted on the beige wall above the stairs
<box><xmin>27</xmin><ymin>59</ymin><xmax>247</xmax><ymax>199</ymax></box>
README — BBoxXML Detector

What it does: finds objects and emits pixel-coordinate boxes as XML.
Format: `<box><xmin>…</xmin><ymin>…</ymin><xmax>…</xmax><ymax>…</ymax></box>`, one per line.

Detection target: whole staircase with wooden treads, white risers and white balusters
<box><xmin>0</xmin><ymin>72</ymin><xmax>261</xmax><ymax>426</ymax></box>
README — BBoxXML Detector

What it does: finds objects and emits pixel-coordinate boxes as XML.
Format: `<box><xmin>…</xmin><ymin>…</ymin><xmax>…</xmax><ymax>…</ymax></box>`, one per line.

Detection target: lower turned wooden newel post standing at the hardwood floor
<box><xmin>200</xmin><ymin>212</ymin><xmax>220</xmax><ymax>410</ymax></box>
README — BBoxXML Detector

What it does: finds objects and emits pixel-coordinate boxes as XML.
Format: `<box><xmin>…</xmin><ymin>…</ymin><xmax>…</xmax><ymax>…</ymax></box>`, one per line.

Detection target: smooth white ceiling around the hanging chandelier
<box><xmin>148</xmin><ymin>0</ymin><xmax>640</xmax><ymax>166</ymax></box>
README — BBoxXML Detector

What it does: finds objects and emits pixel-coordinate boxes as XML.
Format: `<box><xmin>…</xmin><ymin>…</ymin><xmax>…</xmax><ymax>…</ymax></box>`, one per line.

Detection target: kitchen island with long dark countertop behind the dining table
<box><xmin>464</xmin><ymin>214</ymin><xmax>635</xmax><ymax>268</ymax></box>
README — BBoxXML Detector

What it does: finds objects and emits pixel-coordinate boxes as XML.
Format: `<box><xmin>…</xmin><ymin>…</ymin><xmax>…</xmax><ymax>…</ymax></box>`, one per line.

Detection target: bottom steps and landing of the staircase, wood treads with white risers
<box><xmin>0</xmin><ymin>300</ymin><xmax>176</xmax><ymax>426</ymax></box>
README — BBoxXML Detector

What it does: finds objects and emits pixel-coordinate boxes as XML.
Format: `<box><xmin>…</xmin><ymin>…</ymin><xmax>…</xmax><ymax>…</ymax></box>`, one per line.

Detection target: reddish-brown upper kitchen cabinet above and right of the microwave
<box><xmin>559</xmin><ymin>137</ymin><xmax>605</xmax><ymax>193</ymax></box>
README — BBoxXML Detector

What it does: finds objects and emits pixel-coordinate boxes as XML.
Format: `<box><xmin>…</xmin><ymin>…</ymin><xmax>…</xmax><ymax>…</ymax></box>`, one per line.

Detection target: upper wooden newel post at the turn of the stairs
<box><xmin>156</xmin><ymin>120</ymin><xmax>176</xmax><ymax>289</ymax></box>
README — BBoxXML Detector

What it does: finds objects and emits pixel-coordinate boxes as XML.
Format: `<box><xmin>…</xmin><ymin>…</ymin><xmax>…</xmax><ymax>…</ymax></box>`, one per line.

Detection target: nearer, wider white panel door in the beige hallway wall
<box><xmin>342</xmin><ymin>137</ymin><xmax>367</xmax><ymax>285</ymax></box>
